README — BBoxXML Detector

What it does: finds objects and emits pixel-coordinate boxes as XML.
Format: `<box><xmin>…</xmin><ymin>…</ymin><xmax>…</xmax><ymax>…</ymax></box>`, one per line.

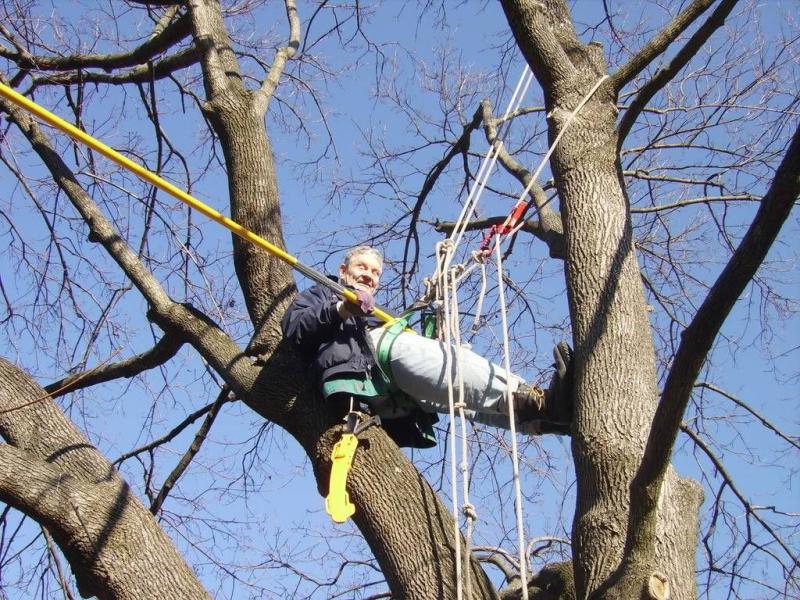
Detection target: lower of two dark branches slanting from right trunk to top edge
<box><xmin>617</xmin><ymin>0</ymin><xmax>739</xmax><ymax>148</ymax></box>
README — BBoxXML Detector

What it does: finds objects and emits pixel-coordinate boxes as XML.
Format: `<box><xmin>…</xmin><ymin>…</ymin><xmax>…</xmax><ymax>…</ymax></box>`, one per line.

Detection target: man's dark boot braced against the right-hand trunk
<box><xmin>514</xmin><ymin>342</ymin><xmax>574</xmax><ymax>435</ymax></box>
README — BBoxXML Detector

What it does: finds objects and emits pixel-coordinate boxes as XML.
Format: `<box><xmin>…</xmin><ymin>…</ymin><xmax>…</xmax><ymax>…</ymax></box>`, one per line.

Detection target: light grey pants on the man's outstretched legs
<box><xmin>367</xmin><ymin>328</ymin><xmax>524</xmax><ymax>428</ymax></box>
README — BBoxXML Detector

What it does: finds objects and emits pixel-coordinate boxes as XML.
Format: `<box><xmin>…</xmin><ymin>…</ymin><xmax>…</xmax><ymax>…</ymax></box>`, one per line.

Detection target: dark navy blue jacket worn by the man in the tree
<box><xmin>281</xmin><ymin>285</ymin><xmax>378</xmax><ymax>384</ymax></box>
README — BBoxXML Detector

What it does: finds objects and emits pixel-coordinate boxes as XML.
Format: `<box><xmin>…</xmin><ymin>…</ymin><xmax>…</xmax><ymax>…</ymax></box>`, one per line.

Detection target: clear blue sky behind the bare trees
<box><xmin>2</xmin><ymin>0</ymin><xmax>800</xmax><ymax>598</ymax></box>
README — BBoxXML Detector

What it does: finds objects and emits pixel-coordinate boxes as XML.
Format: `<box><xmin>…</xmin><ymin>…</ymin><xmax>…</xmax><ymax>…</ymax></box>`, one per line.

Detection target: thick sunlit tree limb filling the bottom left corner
<box><xmin>0</xmin><ymin>358</ymin><xmax>208</xmax><ymax>600</ymax></box>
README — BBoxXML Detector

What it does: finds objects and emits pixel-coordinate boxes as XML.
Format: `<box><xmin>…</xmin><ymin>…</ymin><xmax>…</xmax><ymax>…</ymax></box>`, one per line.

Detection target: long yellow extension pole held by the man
<box><xmin>0</xmin><ymin>82</ymin><xmax>394</xmax><ymax>323</ymax></box>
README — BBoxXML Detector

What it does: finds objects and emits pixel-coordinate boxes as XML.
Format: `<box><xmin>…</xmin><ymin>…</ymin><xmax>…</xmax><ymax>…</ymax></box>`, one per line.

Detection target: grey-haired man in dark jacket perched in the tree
<box><xmin>283</xmin><ymin>246</ymin><xmax>572</xmax><ymax>447</ymax></box>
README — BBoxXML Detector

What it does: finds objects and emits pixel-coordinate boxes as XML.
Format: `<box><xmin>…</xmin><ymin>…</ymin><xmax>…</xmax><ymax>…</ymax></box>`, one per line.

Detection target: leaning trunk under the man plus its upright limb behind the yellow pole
<box><xmin>190</xmin><ymin>0</ymin><xmax>494</xmax><ymax>599</ymax></box>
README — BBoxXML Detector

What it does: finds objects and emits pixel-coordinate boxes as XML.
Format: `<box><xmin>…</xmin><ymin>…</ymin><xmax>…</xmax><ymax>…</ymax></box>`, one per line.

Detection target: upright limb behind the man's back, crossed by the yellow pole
<box><xmin>189</xmin><ymin>0</ymin><xmax>295</xmax><ymax>354</ymax></box>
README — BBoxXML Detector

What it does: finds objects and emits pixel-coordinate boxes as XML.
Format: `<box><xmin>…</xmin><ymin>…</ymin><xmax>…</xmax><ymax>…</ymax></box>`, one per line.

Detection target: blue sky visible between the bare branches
<box><xmin>1</xmin><ymin>0</ymin><xmax>800</xmax><ymax>598</ymax></box>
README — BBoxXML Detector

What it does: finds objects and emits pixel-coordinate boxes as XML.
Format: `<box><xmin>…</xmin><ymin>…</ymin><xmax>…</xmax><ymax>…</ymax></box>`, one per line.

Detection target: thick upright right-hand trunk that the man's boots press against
<box><xmin>503</xmin><ymin>0</ymin><xmax>699</xmax><ymax>598</ymax></box>
